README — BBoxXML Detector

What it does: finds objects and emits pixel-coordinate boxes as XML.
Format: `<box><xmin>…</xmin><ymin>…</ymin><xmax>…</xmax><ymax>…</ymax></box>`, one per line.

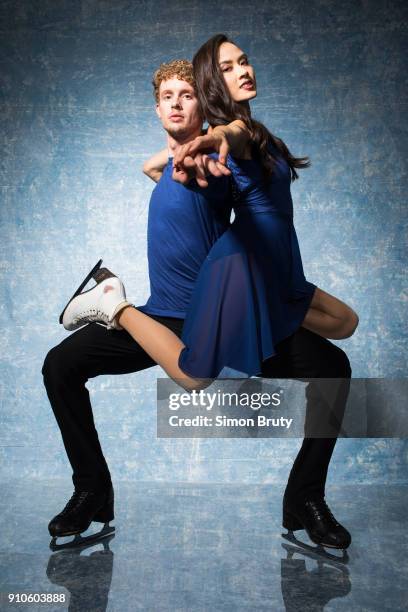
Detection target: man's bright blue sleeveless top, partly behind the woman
<box><xmin>138</xmin><ymin>158</ymin><xmax>232</xmax><ymax>319</ymax></box>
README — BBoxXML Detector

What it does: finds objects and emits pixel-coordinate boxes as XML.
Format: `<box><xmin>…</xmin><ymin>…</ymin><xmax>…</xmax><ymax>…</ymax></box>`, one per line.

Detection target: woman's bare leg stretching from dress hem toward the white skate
<box><xmin>116</xmin><ymin>306</ymin><xmax>212</xmax><ymax>391</ymax></box>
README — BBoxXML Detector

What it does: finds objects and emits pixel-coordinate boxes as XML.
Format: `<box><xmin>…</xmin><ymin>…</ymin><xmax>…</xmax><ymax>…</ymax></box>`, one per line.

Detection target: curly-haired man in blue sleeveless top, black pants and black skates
<box><xmin>43</xmin><ymin>62</ymin><xmax>351</xmax><ymax>548</ymax></box>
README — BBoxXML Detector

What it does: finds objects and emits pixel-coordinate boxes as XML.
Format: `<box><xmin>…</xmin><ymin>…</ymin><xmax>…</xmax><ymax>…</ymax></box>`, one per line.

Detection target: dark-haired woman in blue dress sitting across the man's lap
<box><xmin>60</xmin><ymin>35</ymin><xmax>358</xmax><ymax>389</ymax></box>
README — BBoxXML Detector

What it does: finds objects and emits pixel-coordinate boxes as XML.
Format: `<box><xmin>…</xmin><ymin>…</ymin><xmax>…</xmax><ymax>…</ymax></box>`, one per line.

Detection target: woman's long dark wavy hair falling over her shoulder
<box><xmin>193</xmin><ymin>34</ymin><xmax>310</xmax><ymax>181</ymax></box>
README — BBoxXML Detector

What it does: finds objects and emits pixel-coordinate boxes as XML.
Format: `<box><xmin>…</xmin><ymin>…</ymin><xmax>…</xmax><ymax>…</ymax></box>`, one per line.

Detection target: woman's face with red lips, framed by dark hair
<box><xmin>218</xmin><ymin>43</ymin><xmax>256</xmax><ymax>102</ymax></box>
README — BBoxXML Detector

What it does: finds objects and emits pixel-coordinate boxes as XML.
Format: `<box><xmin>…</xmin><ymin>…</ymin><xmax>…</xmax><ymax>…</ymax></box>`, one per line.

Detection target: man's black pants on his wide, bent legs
<box><xmin>42</xmin><ymin>316</ymin><xmax>351</xmax><ymax>497</ymax></box>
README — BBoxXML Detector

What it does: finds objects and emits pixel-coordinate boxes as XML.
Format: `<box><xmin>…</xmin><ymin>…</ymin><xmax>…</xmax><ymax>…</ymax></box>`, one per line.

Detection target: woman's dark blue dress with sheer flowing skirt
<box><xmin>179</xmin><ymin>143</ymin><xmax>316</xmax><ymax>378</ymax></box>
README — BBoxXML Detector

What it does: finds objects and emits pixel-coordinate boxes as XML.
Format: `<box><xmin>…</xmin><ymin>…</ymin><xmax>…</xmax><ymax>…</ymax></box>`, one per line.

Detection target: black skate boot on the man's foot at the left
<box><xmin>48</xmin><ymin>486</ymin><xmax>114</xmax><ymax>538</ymax></box>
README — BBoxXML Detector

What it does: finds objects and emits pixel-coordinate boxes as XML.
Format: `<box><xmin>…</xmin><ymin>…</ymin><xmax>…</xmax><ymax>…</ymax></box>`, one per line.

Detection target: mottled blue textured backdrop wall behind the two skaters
<box><xmin>0</xmin><ymin>0</ymin><xmax>408</xmax><ymax>483</ymax></box>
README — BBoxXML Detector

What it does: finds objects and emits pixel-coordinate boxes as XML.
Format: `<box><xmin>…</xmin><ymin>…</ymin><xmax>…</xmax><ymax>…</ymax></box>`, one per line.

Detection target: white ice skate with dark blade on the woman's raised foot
<box><xmin>59</xmin><ymin>259</ymin><xmax>131</xmax><ymax>331</ymax></box>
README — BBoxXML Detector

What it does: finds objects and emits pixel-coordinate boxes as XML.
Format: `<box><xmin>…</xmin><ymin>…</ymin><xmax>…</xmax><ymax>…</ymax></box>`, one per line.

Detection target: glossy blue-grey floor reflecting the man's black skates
<box><xmin>0</xmin><ymin>481</ymin><xmax>408</xmax><ymax>612</ymax></box>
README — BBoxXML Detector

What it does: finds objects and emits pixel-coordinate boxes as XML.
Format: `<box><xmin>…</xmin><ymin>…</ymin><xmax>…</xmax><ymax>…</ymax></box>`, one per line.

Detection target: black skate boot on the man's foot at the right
<box><xmin>283</xmin><ymin>497</ymin><xmax>351</xmax><ymax>550</ymax></box>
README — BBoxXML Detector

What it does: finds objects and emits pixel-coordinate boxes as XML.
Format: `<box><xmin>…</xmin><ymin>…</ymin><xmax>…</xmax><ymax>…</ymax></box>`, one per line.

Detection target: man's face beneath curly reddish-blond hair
<box><xmin>156</xmin><ymin>77</ymin><xmax>203</xmax><ymax>140</ymax></box>
